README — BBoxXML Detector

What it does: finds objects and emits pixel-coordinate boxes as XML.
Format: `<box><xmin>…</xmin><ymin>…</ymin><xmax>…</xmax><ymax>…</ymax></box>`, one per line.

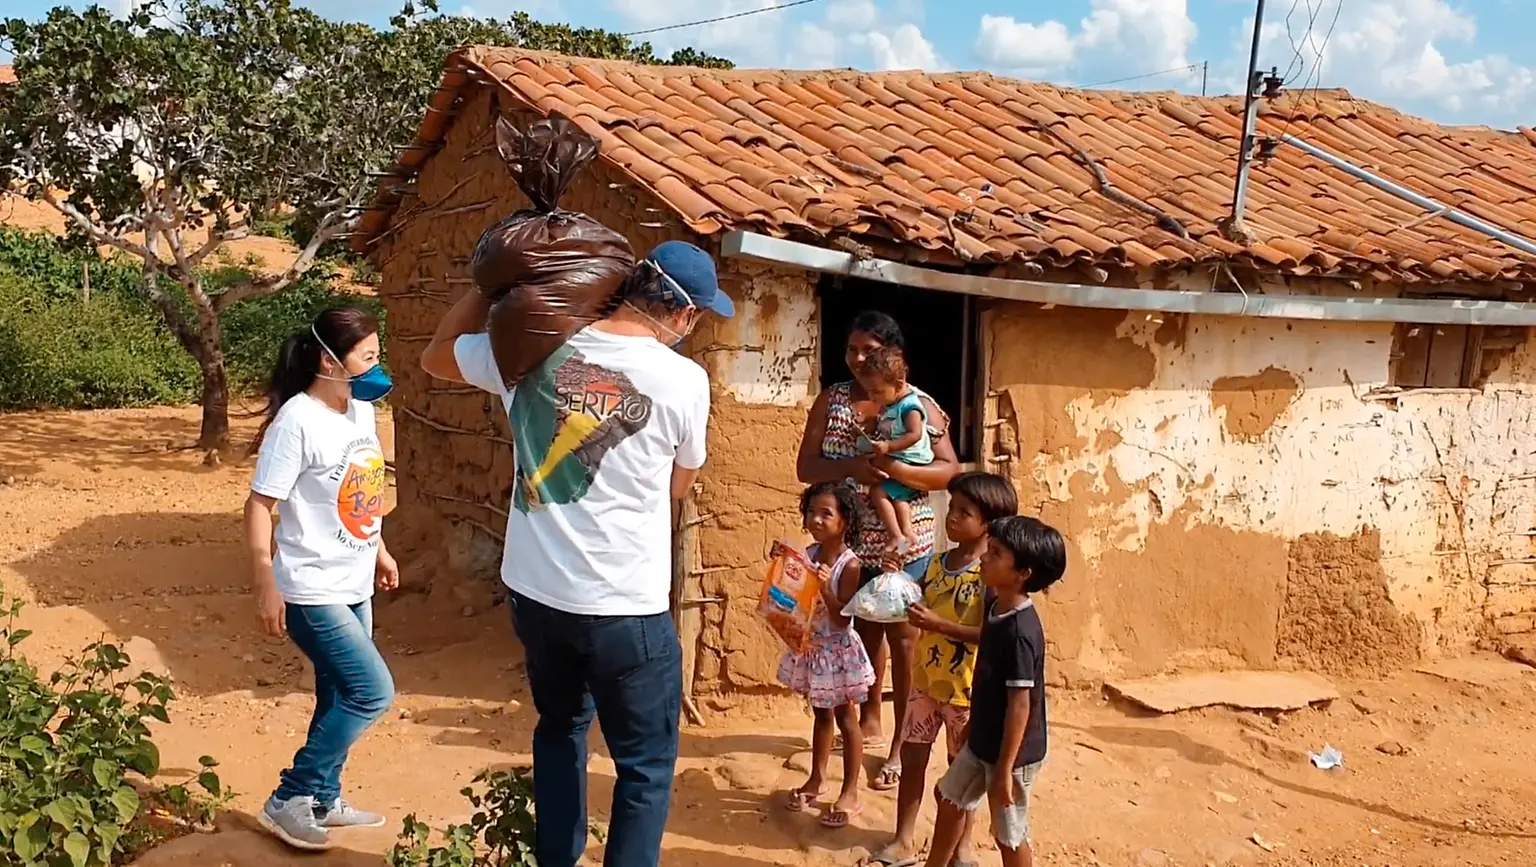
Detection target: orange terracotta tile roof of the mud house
<box><xmin>359</xmin><ymin>46</ymin><xmax>1536</xmax><ymax>281</ymax></box>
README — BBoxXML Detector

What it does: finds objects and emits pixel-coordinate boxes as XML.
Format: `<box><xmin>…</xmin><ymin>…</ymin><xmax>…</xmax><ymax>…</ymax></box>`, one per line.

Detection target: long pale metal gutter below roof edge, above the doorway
<box><xmin>720</xmin><ymin>231</ymin><xmax>1536</xmax><ymax>326</ymax></box>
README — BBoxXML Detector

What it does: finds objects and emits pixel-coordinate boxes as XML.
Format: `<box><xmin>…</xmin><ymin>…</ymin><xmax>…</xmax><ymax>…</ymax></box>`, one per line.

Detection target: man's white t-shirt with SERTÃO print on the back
<box><xmin>453</xmin><ymin>327</ymin><xmax>710</xmax><ymax>615</ymax></box>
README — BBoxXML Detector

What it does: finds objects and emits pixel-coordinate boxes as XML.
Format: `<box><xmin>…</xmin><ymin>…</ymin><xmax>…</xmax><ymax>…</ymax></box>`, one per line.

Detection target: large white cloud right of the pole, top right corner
<box><xmin>1249</xmin><ymin>0</ymin><xmax>1536</xmax><ymax>126</ymax></box>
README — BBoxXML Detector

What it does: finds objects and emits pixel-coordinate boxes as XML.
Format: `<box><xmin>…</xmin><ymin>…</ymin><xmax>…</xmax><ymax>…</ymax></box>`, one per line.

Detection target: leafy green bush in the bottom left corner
<box><xmin>0</xmin><ymin>592</ymin><xmax>232</xmax><ymax>867</ymax></box>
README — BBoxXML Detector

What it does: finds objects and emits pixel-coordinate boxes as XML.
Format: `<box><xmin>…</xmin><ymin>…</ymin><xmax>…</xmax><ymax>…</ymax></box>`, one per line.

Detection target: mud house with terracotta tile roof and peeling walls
<box><xmin>358</xmin><ymin>48</ymin><xmax>1536</xmax><ymax>692</ymax></box>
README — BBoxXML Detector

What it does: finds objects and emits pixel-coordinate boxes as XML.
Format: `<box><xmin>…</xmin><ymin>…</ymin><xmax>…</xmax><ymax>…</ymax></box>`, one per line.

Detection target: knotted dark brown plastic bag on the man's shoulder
<box><xmin>470</xmin><ymin>114</ymin><xmax>634</xmax><ymax>387</ymax></box>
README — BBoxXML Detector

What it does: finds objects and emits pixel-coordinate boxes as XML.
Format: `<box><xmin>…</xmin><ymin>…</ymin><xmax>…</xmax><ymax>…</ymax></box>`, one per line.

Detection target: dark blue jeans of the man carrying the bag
<box><xmin>511</xmin><ymin>592</ymin><xmax>682</xmax><ymax>867</ymax></box>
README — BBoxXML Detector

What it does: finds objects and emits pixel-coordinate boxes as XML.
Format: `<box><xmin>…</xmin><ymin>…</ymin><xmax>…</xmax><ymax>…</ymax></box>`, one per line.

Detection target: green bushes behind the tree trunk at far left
<box><xmin>0</xmin><ymin>226</ymin><xmax>384</xmax><ymax>409</ymax></box>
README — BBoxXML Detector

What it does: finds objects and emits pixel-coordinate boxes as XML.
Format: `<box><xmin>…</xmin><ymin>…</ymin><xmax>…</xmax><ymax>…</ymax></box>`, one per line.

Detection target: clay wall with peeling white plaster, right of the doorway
<box><xmin>985</xmin><ymin>298</ymin><xmax>1536</xmax><ymax>679</ymax></box>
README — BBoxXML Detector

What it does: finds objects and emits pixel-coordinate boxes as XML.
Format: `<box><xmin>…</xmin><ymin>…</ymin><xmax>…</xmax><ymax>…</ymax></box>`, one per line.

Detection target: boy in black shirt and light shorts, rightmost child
<box><xmin>926</xmin><ymin>518</ymin><xmax>1066</xmax><ymax>867</ymax></box>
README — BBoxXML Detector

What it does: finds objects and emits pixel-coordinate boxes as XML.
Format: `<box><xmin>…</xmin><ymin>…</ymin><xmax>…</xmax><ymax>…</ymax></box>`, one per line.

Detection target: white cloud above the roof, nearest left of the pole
<box><xmin>975</xmin><ymin>0</ymin><xmax>1197</xmax><ymax>88</ymax></box>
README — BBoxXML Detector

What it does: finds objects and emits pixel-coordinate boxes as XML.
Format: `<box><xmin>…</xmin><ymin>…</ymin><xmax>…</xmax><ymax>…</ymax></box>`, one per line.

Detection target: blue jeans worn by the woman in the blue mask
<box><xmin>272</xmin><ymin>600</ymin><xmax>395</xmax><ymax>807</ymax></box>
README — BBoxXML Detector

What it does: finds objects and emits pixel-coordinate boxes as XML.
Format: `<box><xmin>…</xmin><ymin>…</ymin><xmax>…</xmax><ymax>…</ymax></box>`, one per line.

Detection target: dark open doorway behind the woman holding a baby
<box><xmin>820</xmin><ymin>277</ymin><xmax>980</xmax><ymax>461</ymax></box>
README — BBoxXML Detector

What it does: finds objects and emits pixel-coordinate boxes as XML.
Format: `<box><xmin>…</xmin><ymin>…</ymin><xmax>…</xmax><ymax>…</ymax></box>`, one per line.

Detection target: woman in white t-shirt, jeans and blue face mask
<box><xmin>246</xmin><ymin>307</ymin><xmax>399</xmax><ymax>850</ymax></box>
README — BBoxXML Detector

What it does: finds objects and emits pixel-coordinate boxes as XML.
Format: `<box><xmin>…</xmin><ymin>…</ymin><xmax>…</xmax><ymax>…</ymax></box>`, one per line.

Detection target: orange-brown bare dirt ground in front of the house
<box><xmin>0</xmin><ymin>409</ymin><xmax>1536</xmax><ymax>867</ymax></box>
